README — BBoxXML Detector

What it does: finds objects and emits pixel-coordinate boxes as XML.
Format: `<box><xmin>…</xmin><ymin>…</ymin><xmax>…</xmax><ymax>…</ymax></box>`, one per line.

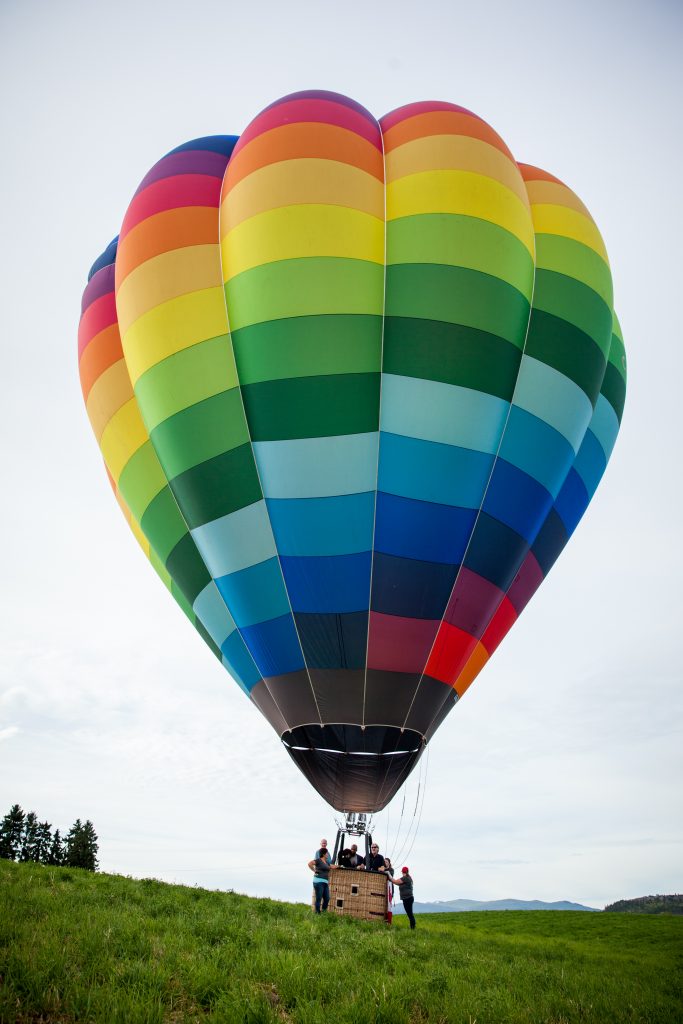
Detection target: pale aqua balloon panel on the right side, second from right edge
<box><xmin>513</xmin><ymin>355</ymin><xmax>593</xmax><ymax>454</ymax></box>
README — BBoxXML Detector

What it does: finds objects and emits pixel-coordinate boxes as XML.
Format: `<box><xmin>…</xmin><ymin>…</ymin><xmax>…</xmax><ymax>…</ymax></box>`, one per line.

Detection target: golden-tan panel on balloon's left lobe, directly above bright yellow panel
<box><xmin>116</xmin><ymin>240</ymin><xmax>222</xmax><ymax>334</ymax></box>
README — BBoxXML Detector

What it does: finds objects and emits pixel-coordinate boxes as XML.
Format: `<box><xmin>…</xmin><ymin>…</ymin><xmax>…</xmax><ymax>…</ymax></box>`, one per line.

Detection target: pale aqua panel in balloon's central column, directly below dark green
<box><xmin>253</xmin><ymin>431</ymin><xmax>379</xmax><ymax>498</ymax></box>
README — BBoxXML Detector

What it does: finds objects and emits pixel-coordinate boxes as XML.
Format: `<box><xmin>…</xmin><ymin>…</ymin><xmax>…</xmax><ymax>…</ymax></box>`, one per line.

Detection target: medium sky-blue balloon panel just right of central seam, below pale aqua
<box><xmin>378</xmin><ymin>433</ymin><xmax>494</xmax><ymax>509</ymax></box>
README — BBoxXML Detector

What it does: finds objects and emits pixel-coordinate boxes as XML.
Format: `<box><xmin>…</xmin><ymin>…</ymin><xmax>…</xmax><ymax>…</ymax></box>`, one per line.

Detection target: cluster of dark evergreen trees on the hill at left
<box><xmin>0</xmin><ymin>804</ymin><xmax>99</xmax><ymax>871</ymax></box>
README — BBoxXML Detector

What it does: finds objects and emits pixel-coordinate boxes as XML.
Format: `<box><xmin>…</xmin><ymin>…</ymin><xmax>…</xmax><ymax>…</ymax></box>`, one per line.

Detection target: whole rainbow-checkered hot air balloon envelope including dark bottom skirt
<box><xmin>79</xmin><ymin>91</ymin><xmax>626</xmax><ymax>811</ymax></box>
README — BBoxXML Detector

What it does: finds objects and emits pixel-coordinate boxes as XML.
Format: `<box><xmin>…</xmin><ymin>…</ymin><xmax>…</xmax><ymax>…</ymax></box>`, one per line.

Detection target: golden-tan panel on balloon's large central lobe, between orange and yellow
<box><xmin>220</xmin><ymin>159</ymin><xmax>384</xmax><ymax>239</ymax></box>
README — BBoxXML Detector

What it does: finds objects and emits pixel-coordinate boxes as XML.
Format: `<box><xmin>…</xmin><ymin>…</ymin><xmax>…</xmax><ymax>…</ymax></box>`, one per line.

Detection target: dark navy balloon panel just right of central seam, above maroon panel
<box><xmin>372</xmin><ymin>551</ymin><xmax>458</xmax><ymax>620</ymax></box>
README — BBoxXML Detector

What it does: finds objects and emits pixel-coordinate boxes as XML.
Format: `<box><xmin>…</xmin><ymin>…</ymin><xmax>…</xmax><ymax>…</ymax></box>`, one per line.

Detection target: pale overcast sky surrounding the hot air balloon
<box><xmin>0</xmin><ymin>0</ymin><xmax>683</xmax><ymax>906</ymax></box>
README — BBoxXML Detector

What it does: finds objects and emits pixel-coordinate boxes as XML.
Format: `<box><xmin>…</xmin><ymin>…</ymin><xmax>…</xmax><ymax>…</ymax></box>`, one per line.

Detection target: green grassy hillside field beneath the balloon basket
<box><xmin>0</xmin><ymin>860</ymin><xmax>683</xmax><ymax>1024</ymax></box>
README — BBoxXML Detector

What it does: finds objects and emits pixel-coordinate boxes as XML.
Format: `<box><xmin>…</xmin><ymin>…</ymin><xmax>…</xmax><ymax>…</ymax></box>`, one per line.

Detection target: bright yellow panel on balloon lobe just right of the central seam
<box><xmin>387</xmin><ymin>171</ymin><xmax>535</xmax><ymax>256</ymax></box>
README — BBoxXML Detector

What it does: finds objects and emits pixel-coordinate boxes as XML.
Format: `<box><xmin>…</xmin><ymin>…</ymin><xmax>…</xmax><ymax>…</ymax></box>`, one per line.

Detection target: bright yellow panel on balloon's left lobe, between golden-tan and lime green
<box><xmin>123</xmin><ymin>288</ymin><xmax>229</xmax><ymax>387</ymax></box>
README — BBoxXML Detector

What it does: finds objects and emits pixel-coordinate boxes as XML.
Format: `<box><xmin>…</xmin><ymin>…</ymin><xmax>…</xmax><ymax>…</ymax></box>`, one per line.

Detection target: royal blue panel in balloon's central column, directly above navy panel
<box><xmin>282</xmin><ymin>551</ymin><xmax>372</xmax><ymax>612</ymax></box>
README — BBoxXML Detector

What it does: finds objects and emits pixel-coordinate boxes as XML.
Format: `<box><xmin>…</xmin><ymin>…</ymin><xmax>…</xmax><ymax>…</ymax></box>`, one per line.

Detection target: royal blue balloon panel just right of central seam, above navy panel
<box><xmin>375</xmin><ymin>490</ymin><xmax>476</xmax><ymax>565</ymax></box>
